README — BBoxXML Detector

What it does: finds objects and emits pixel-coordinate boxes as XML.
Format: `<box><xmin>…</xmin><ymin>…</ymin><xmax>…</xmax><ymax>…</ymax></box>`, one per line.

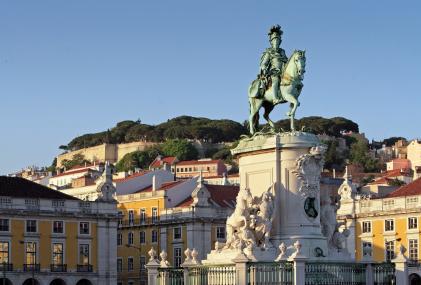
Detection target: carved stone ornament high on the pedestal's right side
<box><xmin>295</xmin><ymin>145</ymin><xmax>326</xmax><ymax>198</ymax></box>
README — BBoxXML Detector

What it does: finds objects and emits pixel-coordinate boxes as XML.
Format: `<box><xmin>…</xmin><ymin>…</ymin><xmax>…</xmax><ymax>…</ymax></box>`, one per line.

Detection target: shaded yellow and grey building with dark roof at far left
<box><xmin>0</xmin><ymin>177</ymin><xmax>117</xmax><ymax>285</ymax></box>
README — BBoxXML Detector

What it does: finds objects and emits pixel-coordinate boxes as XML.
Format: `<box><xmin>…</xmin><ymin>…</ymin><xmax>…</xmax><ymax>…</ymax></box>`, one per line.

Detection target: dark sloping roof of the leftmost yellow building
<box><xmin>0</xmin><ymin>176</ymin><xmax>79</xmax><ymax>200</ymax></box>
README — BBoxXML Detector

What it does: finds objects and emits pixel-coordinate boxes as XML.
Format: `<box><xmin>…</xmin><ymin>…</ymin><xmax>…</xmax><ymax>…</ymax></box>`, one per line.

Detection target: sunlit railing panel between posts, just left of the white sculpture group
<box><xmin>188</xmin><ymin>264</ymin><xmax>236</xmax><ymax>285</ymax></box>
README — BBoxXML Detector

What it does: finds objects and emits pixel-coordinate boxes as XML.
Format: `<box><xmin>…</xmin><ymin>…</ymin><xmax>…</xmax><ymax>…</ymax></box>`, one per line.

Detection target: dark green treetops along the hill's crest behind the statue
<box><xmin>60</xmin><ymin>116</ymin><xmax>358</xmax><ymax>151</ymax></box>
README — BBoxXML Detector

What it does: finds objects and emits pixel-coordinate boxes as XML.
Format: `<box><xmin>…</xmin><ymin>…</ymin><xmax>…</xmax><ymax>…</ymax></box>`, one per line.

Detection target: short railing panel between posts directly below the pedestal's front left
<box><xmin>247</xmin><ymin>261</ymin><xmax>294</xmax><ymax>285</ymax></box>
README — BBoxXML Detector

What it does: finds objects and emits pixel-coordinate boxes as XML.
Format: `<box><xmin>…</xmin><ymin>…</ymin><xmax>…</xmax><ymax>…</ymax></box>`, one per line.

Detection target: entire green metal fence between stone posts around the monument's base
<box><xmin>156</xmin><ymin>261</ymin><xmax>396</xmax><ymax>285</ymax></box>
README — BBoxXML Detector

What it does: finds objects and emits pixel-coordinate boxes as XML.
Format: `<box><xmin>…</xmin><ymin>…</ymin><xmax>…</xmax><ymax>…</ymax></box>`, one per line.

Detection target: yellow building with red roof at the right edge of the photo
<box><xmin>338</xmin><ymin>176</ymin><xmax>421</xmax><ymax>281</ymax></box>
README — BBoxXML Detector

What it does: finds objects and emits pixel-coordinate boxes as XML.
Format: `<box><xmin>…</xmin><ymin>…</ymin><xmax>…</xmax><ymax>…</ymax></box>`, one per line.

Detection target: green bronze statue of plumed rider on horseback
<box><xmin>248</xmin><ymin>25</ymin><xmax>306</xmax><ymax>135</ymax></box>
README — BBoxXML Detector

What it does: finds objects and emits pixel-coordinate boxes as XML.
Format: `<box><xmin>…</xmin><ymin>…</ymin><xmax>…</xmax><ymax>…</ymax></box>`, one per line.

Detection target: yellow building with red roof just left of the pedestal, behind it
<box><xmin>117</xmin><ymin>178</ymin><xmax>238</xmax><ymax>285</ymax></box>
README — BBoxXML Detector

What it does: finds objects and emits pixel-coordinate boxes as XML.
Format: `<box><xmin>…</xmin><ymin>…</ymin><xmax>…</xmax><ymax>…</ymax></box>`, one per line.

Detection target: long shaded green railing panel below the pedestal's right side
<box><xmin>305</xmin><ymin>262</ymin><xmax>366</xmax><ymax>285</ymax></box>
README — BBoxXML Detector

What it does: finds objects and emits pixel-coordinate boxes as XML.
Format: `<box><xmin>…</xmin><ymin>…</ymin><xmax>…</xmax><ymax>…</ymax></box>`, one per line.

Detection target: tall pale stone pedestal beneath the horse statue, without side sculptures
<box><xmin>232</xmin><ymin>132</ymin><xmax>328</xmax><ymax>259</ymax></box>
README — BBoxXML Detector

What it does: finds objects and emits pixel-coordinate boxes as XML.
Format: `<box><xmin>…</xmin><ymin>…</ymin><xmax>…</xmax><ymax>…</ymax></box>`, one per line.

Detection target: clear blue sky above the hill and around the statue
<box><xmin>0</xmin><ymin>0</ymin><xmax>421</xmax><ymax>174</ymax></box>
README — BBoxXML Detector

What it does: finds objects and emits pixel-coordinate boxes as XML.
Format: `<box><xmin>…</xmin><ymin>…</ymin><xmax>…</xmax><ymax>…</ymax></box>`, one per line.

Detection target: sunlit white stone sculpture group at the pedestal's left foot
<box><xmin>224</xmin><ymin>187</ymin><xmax>274</xmax><ymax>250</ymax></box>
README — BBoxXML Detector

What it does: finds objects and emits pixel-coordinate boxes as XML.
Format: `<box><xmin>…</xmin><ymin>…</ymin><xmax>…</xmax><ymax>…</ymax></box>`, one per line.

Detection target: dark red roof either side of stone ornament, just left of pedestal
<box><xmin>176</xmin><ymin>184</ymin><xmax>240</xmax><ymax>208</ymax></box>
